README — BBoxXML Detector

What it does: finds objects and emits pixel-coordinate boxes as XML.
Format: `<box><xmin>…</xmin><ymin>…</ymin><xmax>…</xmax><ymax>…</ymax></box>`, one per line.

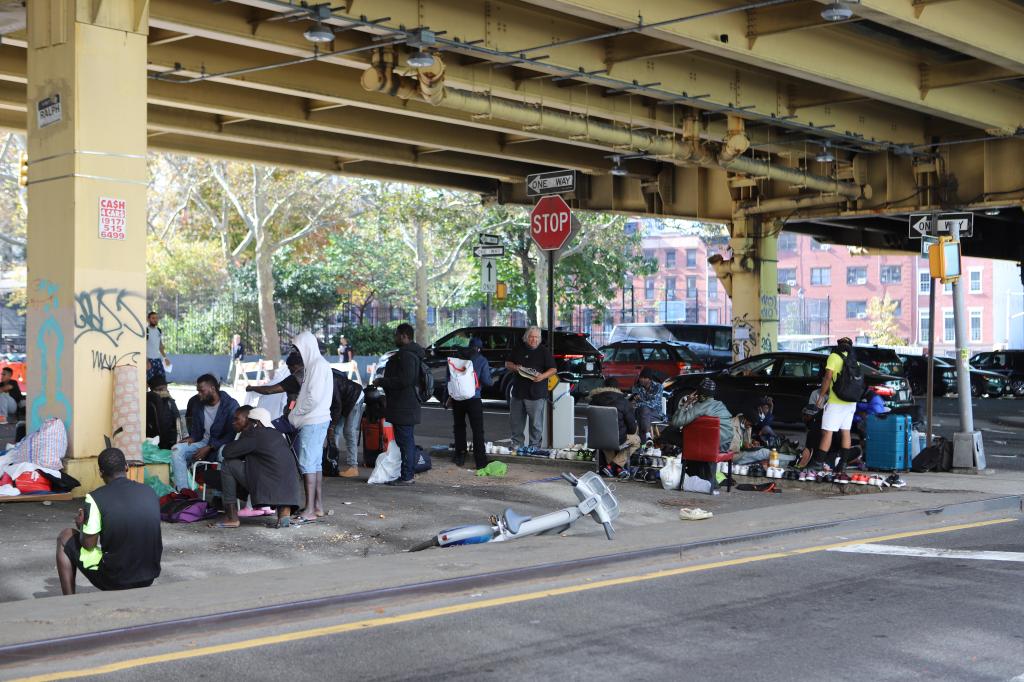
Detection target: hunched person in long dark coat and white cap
<box><xmin>214</xmin><ymin>406</ymin><xmax>302</xmax><ymax>528</ymax></box>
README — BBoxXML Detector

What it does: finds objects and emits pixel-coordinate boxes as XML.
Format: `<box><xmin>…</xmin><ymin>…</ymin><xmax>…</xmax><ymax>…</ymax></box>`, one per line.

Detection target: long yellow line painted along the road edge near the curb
<box><xmin>12</xmin><ymin>518</ymin><xmax>1017</xmax><ymax>682</ymax></box>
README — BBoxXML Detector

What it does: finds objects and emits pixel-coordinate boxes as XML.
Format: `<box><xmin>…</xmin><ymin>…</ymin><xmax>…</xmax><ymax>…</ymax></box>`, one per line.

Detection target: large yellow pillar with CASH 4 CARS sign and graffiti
<box><xmin>27</xmin><ymin>0</ymin><xmax>148</xmax><ymax>495</ymax></box>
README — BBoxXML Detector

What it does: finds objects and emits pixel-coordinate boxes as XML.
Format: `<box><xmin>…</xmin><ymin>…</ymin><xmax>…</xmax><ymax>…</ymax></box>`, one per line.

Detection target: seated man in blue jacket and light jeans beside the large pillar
<box><xmin>171</xmin><ymin>374</ymin><xmax>239</xmax><ymax>491</ymax></box>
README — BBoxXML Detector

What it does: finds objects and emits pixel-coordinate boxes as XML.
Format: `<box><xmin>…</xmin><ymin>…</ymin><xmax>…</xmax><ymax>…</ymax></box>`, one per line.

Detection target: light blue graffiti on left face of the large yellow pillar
<box><xmin>29</xmin><ymin>280</ymin><xmax>72</xmax><ymax>431</ymax></box>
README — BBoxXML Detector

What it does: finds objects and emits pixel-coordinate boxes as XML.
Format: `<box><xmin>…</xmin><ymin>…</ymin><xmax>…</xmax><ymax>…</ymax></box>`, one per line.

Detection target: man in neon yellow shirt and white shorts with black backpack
<box><xmin>814</xmin><ymin>337</ymin><xmax>864</xmax><ymax>472</ymax></box>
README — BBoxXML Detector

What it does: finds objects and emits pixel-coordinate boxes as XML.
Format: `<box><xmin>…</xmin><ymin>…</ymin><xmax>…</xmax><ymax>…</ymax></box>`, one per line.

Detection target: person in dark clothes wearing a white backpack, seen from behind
<box><xmin>447</xmin><ymin>336</ymin><xmax>495</xmax><ymax>469</ymax></box>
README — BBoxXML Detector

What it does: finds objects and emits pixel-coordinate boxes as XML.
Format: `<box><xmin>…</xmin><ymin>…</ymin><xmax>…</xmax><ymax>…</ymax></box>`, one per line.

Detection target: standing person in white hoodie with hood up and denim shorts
<box><xmin>288</xmin><ymin>332</ymin><xmax>334</xmax><ymax>523</ymax></box>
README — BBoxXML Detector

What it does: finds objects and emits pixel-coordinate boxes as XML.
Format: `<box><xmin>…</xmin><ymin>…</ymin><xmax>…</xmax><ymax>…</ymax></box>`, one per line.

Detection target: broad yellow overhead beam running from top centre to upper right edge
<box><xmin>524</xmin><ymin>0</ymin><xmax>1024</xmax><ymax>134</ymax></box>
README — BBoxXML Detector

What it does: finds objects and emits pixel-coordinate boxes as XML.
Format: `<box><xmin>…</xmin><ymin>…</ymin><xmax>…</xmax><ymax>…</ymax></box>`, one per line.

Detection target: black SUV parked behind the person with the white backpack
<box><xmin>374</xmin><ymin>327</ymin><xmax>604</xmax><ymax>401</ymax></box>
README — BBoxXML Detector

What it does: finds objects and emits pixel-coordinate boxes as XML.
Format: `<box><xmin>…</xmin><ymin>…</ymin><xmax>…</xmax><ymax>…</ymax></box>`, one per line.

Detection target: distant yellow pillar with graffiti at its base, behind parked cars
<box><xmin>710</xmin><ymin>215</ymin><xmax>778</xmax><ymax>360</ymax></box>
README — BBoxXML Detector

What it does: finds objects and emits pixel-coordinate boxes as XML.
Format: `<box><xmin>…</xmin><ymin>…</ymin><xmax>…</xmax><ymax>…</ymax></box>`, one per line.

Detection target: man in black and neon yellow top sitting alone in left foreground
<box><xmin>57</xmin><ymin>447</ymin><xmax>164</xmax><ymax>595</ymax></box>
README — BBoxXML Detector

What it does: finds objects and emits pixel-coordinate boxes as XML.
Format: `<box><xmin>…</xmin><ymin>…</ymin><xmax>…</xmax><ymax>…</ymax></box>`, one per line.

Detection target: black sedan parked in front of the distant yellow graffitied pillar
<box><xmin>665</xmin><ymin>352</ymin><xmax>914</xmax><ymax>422</ymax></box>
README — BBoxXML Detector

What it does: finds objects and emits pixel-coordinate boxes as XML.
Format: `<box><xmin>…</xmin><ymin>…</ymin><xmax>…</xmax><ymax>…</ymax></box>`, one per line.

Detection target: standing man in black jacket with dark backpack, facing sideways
<box><xmin>374</xmin><ymin>323</ymin><xmax>429</xmax><ymax>485</ymax></box>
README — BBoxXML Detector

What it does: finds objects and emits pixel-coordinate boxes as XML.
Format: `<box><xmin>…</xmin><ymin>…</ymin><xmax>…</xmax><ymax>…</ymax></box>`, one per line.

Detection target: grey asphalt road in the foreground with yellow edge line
<box><xmin>9</xmin><ymin>515</ymin><xmax>1024</xmax><ymax>682</ymax></box>
